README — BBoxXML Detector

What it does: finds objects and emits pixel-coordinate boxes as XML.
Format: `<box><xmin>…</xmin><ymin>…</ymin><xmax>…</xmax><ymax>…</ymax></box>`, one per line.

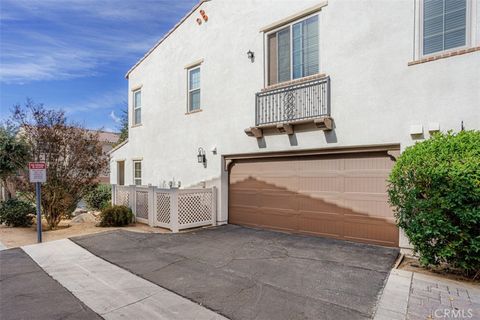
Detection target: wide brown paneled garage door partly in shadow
<box><xmin>229</xmin><ymin>152</ymin><xmax>398</xmax><ymax>246</ymax></box>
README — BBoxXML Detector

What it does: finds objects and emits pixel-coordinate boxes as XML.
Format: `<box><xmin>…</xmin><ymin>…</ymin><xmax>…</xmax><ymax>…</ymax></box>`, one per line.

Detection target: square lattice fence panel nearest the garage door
<box><xmin>178</xmin><ymin>191</ymin><xmax>213</xmax><ymax>225</ymax></box>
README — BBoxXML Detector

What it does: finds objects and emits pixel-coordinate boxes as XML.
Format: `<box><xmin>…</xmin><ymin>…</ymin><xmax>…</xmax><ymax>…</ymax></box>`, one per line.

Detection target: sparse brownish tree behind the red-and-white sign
<box><xmin>12</xmin><ymin>100</ymin><xmax>108</xmax><ymax>229</ymax></box>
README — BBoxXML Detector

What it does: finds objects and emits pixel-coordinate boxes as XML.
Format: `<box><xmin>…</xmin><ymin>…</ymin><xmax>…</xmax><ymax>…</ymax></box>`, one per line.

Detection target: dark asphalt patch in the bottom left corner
<box><xmin>0</xmin><ymin>248</ymin><xmax>101</xmax><ymax>320</ymax></box>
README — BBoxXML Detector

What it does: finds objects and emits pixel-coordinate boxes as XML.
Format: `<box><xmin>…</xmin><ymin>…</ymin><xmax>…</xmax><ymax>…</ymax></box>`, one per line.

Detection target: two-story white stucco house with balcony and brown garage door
<box><xmin>111</xmin><ymin>0</ymin><xmax>480</xmax><ymax>247</ymax></box>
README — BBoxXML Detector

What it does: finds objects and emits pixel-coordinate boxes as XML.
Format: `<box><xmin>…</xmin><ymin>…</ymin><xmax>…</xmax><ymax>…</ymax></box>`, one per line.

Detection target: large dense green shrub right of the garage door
<box><xmin>388</xmin><ymin>131</ymin><xmax>480</xmax><ymax>274</ymax></box>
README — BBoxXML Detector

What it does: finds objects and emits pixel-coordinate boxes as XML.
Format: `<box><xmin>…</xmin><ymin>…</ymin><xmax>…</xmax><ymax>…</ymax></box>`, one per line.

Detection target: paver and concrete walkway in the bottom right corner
<box><xmin>374</xmin><ymin>269</ymin><xmax>480</xmax><ymax>320</ymax></box>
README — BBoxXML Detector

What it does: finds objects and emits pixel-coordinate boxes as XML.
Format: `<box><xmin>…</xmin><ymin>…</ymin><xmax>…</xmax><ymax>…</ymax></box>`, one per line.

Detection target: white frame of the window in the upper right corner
<box><xmin>415</xmin><ymin>0</ymin><xmax>477</xmax><ymax>59</ymax></box>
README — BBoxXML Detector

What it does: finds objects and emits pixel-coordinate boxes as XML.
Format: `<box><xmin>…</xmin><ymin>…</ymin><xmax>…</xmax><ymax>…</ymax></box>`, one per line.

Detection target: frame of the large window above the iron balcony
<box><xmin>264</xmin><ymin>12</ymin><xmax>322</xmax><ymax>86</ymax></box>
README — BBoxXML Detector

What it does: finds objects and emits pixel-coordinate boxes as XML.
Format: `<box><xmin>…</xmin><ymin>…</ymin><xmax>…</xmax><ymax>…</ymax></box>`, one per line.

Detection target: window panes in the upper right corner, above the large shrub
<box><xmin>421</xmin><ymin>0</ymin><xmax>469</xmax><ymax>55</ymax></box>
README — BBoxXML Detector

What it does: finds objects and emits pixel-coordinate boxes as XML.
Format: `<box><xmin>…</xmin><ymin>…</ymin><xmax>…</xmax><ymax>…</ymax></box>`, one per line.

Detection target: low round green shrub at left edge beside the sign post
<box><xmin>0</xmin><ymin>199</ymin><xmax>35</xmax><ymax>227</ymax></box>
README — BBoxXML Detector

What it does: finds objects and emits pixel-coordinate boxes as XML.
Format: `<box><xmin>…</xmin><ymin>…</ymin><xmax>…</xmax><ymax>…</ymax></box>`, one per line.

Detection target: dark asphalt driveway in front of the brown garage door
<box><xmin>72</xmin><ymin>225</ymin><xmax>398</xmax><ymax>320</ymax></box>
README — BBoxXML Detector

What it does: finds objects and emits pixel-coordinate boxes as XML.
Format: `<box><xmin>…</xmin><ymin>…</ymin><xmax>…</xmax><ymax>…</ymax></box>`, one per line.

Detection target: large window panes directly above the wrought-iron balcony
<box><xmin>267</xmin><ymin>15</ymin><xmax>320</xmax><ymax>85</ymax></box>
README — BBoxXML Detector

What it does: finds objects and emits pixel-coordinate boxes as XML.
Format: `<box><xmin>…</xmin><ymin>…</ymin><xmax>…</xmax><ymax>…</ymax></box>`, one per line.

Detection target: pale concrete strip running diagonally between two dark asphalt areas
<box><xmin>22</xmin><ymin>239</ymin><xmax>225</xmax><ymax>320</ymax></box>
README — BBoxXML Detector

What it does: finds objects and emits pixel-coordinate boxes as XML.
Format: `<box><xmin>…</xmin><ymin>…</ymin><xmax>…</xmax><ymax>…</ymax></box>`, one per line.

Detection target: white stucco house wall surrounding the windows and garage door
<box><xmin>111</xmin><ymin>0</ymin><xmax>480</xmax><ymax>228</ymax></box>
